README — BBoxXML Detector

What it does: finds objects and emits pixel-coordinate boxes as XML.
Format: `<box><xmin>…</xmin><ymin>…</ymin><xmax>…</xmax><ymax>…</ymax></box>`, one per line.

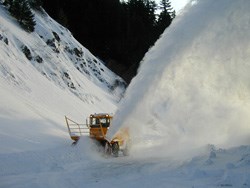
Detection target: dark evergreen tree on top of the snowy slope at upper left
<box><xmin>9</xmin><ymin>0</ymin><xmax>36</xmax><ymax>32</ymax></box>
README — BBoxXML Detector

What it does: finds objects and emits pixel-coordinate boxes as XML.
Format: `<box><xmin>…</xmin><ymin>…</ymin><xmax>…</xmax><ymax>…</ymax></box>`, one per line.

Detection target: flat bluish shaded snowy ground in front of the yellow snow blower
<box><xmin>0</xmin><ymin>138</ymin><xmax>250</xmax><ymax>188</ymax></box>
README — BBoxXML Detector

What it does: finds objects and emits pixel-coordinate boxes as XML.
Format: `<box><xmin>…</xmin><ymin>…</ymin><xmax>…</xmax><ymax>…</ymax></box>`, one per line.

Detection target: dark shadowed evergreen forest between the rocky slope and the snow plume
<box><xmin>43</xmin><ymin>0</ymin><xmax>175</xmax><ymax>82</ymax></box>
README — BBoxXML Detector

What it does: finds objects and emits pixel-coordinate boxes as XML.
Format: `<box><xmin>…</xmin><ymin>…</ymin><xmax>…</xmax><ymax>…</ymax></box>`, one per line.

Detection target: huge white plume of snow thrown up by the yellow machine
<box><xmin>109</xmin><ymin>0</ymin><xmax>250</xmax><ymax>157</ymax></box>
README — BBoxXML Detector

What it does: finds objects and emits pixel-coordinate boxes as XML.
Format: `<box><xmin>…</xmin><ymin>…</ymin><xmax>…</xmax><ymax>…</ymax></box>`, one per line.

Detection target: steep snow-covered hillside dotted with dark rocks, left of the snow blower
<box><xmin>0</xmin><ymin>5</ymin><xmax>125</xmax><ymax>153</ymax></box>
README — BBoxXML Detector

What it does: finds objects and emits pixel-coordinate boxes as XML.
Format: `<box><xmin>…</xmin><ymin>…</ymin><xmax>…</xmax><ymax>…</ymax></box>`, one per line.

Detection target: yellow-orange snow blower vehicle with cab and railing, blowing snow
<box><xmin>65</xmin><ymin>113</ymin><xmax>130</xmax><ymax>157</ymax></box>
